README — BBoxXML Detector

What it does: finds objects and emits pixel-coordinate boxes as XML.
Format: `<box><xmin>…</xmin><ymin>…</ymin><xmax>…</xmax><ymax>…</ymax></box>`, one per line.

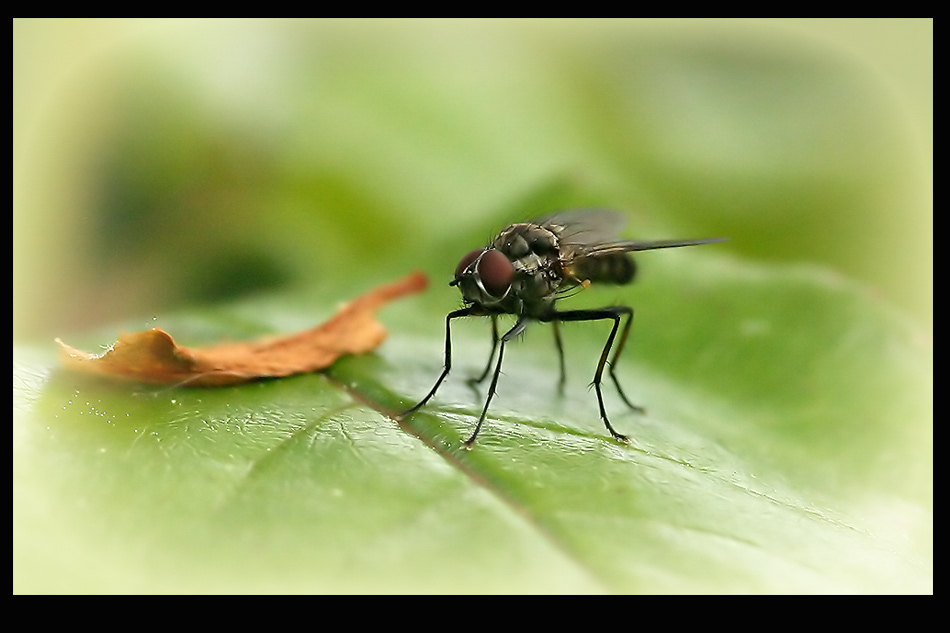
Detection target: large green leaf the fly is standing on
<box><xmin>14</xmin><ymin>253</ymin><xmax>932</xmax><ymax>592</ymax></box>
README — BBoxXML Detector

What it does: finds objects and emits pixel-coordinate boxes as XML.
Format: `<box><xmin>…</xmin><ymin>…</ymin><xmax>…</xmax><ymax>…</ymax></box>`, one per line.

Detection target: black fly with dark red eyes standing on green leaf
<box><xmin>401</xmin><ymin>209</ymin><xmax>722</xmax><ymax>448</ymax></box>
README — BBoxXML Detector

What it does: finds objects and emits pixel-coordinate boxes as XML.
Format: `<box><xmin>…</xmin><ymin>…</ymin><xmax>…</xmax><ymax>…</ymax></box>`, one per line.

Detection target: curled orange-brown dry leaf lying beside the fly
<box><xmin>56</xmin><ymin>272</ymin><xmax>427</xmax><ymax>387</ymax></box>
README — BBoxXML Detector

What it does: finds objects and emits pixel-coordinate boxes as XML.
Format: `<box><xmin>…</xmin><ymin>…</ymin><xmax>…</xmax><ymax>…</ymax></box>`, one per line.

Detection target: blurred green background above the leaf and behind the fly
<box><xmin>13</xmin><ymin>19</ymin><xmax>933</xmax><ymax>339</ymax></box>
